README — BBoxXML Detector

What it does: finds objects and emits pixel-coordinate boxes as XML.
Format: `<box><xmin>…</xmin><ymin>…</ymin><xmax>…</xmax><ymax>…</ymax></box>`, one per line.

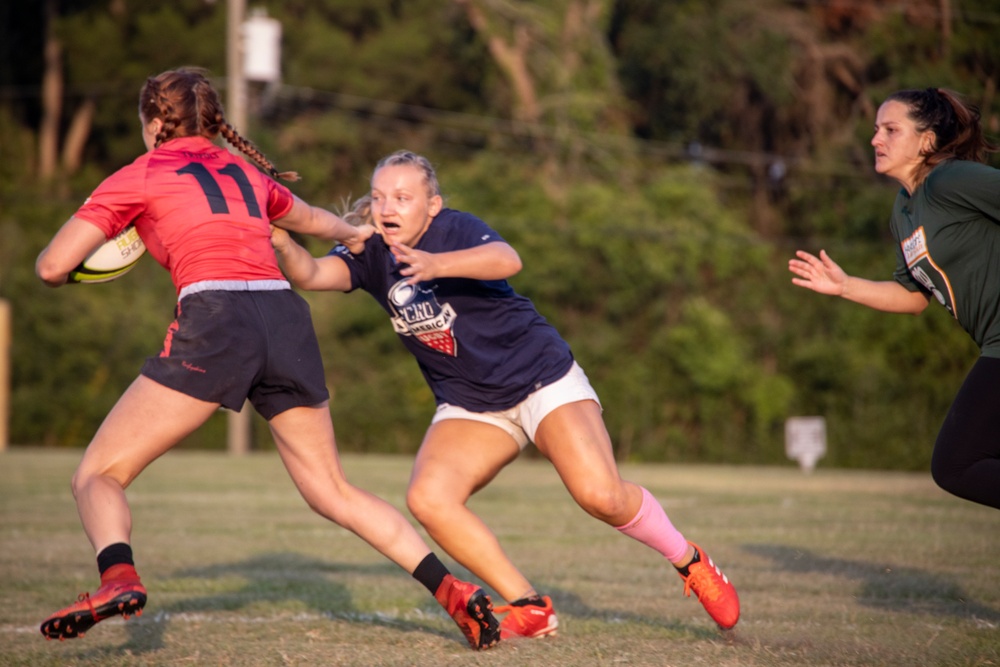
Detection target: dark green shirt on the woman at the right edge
<box><xmin>889</xmin><ymin>160</ymin><xmax>1000</xmax><ymax>357</ymax></box>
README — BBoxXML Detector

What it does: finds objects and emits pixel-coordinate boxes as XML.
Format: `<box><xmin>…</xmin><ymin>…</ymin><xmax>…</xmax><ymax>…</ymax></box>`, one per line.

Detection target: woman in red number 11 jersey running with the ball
<box><xmin>36</xmin><ymin>68</ymin><xmax>500</xmax><ymax>649</ymax></box>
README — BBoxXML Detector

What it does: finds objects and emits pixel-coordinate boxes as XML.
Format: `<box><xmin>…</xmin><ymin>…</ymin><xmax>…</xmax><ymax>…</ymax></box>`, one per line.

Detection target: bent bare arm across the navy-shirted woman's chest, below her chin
<box><xmin>390</xmin><ymin>241</ymin><xmax>521</xmax><ymax>285</ymax></box>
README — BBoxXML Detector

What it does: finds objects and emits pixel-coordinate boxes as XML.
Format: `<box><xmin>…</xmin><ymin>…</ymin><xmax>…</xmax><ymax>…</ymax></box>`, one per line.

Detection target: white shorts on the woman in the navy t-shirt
<box><xmin>431</xmin><ymin>361</ymin><xmax>601</xmax><ymax>449</ymax></box>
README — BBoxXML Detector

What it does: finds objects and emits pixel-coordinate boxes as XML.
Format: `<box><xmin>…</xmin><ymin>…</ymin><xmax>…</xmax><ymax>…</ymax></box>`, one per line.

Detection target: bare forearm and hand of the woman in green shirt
<box><xmin>788</xmin><ymin>250</ymin><xmax>928</xmax><ymax>315</ymax></box>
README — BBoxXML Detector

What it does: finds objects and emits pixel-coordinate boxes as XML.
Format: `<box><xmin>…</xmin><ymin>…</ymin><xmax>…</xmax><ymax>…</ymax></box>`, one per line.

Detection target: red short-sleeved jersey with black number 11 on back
<box><xmin>76</xmin><ymin>137</ymin><xmax>293</xmax><ymax>293</ymax></box>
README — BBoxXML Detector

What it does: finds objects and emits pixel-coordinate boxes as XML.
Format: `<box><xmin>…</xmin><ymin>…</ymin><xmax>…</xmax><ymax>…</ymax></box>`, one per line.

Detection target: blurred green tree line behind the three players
<box><xmin>0</xmin><ymin>0</ymin><xmax>1000</xmax><ymax>469</ymax></box>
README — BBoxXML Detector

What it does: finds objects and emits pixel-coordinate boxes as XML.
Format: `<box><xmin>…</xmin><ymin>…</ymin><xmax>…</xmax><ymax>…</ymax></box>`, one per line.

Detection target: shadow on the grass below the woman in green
<box><xmin>743</xmin><ymin>544</ymin><xmax>1000</xmax><ymax>623</ymax></box>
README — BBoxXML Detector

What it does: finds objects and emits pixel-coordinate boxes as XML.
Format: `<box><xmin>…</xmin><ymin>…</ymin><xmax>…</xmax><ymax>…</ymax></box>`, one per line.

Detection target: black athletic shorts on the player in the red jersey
<box><xmin>142</xmin><ymin>289</ymin><xmax>330</xmax><ymax>420</ymax></box>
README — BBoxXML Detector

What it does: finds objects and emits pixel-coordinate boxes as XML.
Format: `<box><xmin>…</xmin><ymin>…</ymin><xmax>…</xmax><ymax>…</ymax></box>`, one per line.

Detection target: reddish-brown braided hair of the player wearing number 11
<box><xmin>139</xmin><ymin>67</ymin><xmax>299</xmax><ymax>181</ymax></box>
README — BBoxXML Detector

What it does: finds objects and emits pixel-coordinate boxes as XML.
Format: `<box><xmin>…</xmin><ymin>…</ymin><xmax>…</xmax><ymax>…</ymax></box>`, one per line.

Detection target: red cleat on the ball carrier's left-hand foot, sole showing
<box><xmin>41</xmin><ymin>570</ymin><xmax>146</xmax><ymax>640</ymax></box>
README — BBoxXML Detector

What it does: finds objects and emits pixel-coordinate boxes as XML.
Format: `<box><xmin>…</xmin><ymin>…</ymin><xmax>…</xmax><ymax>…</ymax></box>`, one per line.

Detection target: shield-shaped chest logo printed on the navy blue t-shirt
<box><xmin>389</xmin><ymin>280</ymin><xmax>458</xmax><ymax>357</ymax></box>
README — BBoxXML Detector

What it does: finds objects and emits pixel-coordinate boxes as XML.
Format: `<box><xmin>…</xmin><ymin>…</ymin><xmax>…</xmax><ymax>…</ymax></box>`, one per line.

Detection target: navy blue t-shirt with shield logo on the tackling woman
<box><xmin>330</xmin><ymin>209</ymin><xmax>573</xmax><ymax>412</ymax></box>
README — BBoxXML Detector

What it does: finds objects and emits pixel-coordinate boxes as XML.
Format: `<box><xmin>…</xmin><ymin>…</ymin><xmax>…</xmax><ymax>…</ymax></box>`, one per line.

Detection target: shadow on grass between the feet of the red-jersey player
<box><xmin>94</xmin><ymin>553</ymin><xmax>480</xmax><ymax>655</ymax></box>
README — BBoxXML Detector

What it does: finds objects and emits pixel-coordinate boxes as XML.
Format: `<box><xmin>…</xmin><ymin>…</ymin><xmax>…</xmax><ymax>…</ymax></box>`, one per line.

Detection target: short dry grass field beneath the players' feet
<box><xmin>0</xmin><ymin>449</ymin><xmax>1000</xmax><ymax>667</ymax></box>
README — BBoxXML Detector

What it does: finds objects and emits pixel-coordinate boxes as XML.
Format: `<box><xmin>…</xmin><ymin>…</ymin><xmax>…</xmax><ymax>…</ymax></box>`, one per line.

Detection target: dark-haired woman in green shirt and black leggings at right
<box><xmin>788</xmin><ymin>88</ymin><xmax>1000</xmax><ymax>509</ymax></box>
